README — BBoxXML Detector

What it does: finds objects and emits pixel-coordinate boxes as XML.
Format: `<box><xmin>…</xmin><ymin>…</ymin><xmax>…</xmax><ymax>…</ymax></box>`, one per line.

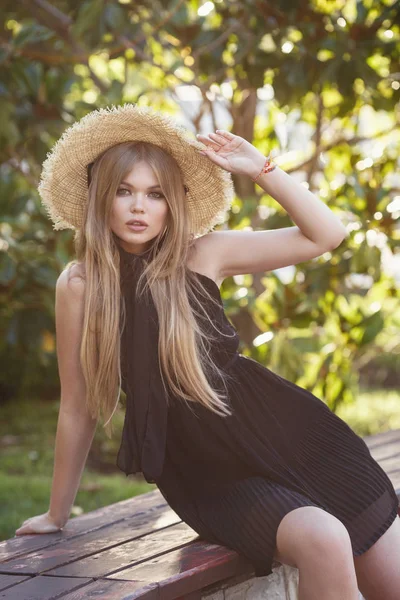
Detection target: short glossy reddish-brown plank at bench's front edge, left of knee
<box><xmin>103</xmin><ymin>541</ymin><xmax>254</xmax><ymax>600</ymax></box>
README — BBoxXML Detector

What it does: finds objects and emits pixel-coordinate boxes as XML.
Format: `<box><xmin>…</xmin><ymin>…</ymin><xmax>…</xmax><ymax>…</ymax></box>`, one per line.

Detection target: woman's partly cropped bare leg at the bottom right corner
<box><xmin>354</xmin><ymin>516</ymin><xmax>400</xmax><ymax>600</ymax></box>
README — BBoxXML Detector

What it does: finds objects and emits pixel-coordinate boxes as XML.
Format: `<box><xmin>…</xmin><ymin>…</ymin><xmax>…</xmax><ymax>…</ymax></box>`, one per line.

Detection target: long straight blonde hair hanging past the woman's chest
<box><xmin>66</xmin><ymin>142</ymin><xmax>231</xmax><ymax>437</ymax></box>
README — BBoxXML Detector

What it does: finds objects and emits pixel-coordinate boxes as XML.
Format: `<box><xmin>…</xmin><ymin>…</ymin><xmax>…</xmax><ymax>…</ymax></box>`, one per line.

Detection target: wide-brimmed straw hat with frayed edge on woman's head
<box><xmin>38</xmin><ymin>103</ymin><xmax>234</xmax><ymax>236</ymax></box>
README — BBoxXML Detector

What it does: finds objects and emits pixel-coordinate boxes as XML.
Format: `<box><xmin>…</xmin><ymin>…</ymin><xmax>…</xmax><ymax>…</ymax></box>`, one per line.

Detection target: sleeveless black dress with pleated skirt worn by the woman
<box><xmin>117</xmin><ymin>248</ymin><xmax>399</xmax><ymax>577</ymax></box>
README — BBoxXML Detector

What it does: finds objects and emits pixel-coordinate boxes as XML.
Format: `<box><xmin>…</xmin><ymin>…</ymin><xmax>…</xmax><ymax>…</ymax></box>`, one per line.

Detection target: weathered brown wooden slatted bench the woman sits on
<box><xmin>0</xmin><ymin>430</ymin><xmax>400</xmax><ymax>600</ymax></box>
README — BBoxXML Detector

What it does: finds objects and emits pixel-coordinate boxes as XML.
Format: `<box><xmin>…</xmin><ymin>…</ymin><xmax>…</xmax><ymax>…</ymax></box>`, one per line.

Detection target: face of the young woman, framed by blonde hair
<box><xmin>110</xmin><ymin>161</ymin><xmax>168</xmax><ymax>254</ymax></box>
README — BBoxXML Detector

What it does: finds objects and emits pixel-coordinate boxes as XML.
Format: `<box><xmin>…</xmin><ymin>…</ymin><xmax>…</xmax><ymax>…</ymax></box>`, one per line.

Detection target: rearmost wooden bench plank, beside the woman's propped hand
<box><xmin>0</xmin><ymin>490</ymin><xmax>175</xmax><ymax>566</ymax></box>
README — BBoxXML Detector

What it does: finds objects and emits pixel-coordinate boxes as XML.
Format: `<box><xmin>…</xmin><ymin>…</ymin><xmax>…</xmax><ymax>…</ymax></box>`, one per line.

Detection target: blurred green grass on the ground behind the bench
<box><xmin>0</xmin><ymin>390</ymin><xmax>400</xmax><ymax>540</ymax></box>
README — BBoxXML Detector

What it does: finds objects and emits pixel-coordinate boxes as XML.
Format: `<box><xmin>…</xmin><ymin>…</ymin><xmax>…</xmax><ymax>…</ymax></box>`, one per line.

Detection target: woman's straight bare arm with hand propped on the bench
<box><xmin>17</xmin><ymin>265</ymin><xmax>97</xmax><ymax>534</ymax></box>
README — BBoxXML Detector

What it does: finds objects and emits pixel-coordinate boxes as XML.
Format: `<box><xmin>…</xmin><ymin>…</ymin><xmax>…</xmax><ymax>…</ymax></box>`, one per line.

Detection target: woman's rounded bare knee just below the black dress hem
<box><xmin>275</xmin><ymin>506</ymin><xmax>351</xmax><ymax>567</ymax></box>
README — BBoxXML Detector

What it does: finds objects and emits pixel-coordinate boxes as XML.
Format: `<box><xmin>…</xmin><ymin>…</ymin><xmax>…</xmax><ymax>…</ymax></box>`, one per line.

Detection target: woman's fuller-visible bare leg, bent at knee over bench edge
<box><xmin>275</xmin><ymin>506</ymin><xmax>360</xmax><ymax>600</ymax></box>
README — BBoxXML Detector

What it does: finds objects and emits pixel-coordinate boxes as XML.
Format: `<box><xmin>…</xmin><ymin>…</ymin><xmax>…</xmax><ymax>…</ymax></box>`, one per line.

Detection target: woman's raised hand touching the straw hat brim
<box><xmin>196</xmin><ymin>129</ymin><xmax>266</xmax><ymax>179</ymax></box>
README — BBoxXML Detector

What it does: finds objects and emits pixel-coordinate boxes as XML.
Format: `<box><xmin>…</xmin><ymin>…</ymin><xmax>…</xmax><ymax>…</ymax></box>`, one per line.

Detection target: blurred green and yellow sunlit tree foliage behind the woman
<box><xmin>0</xmin><ymin>0</ymin><xmax>400</xmax><ymax>536</ymax></box>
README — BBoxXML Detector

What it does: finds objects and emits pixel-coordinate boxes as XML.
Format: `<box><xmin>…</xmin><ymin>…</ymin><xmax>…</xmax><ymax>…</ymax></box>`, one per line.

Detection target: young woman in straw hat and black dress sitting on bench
<box><xmin>16</xmin><ymin>104</ymin><xmax>400</xmax><ymax>600</ymax></box>
